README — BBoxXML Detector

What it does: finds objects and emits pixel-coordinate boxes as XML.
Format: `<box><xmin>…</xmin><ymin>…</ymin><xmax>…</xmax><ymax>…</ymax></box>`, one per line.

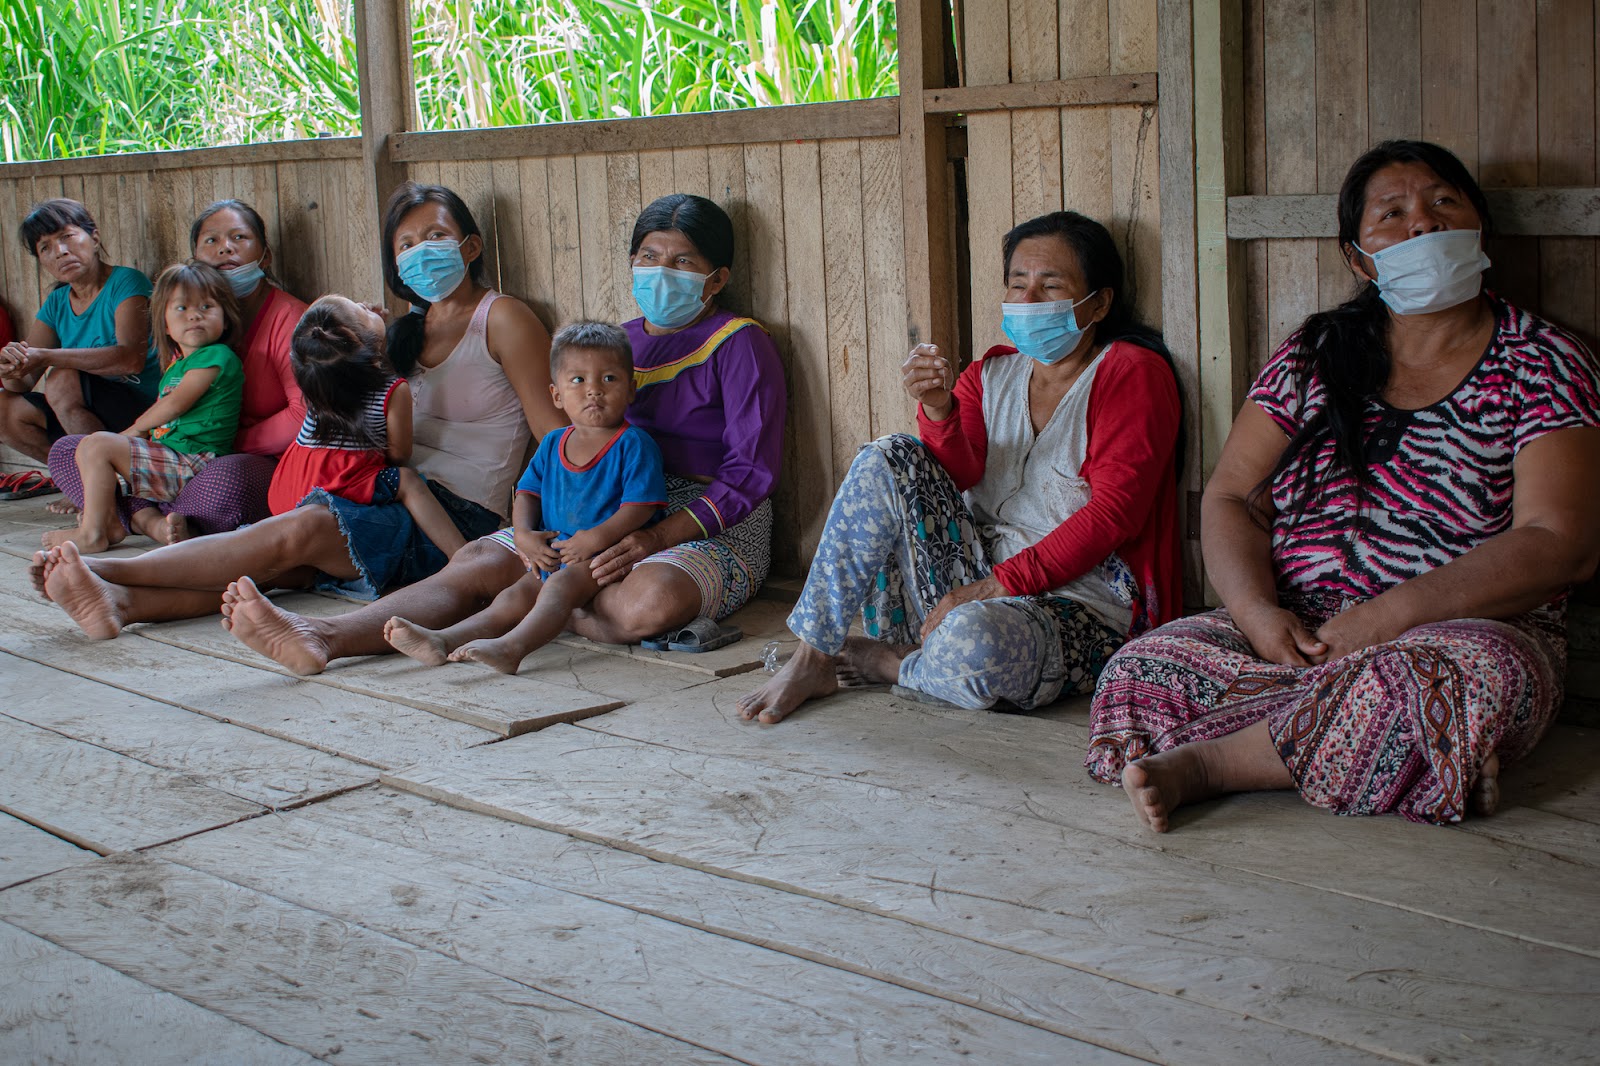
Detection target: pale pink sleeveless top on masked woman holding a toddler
<box><xmin>410</xmin><ymin>291</ymin><xmax>533</xmax><ymax>519</ymax></box>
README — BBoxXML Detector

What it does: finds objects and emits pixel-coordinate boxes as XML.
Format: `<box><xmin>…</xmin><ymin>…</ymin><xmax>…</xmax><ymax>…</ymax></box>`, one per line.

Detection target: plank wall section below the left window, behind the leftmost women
<box><xmin>0</xmin><ymin>146</ymin><xmax>382</xmax><ymax>344</ymax></box>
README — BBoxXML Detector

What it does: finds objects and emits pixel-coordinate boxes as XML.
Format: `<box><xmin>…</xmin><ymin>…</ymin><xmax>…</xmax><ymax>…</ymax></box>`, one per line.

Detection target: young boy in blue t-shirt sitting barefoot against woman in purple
<box><xmin>384</xmin><ymin>322</ymin><xmax>667</xmax><ymax>674</ymax></box>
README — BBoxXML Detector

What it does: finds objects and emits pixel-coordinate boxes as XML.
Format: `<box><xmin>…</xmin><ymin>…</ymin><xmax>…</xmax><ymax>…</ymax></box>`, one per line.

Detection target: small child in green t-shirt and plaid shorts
<box><xmin>43</xmin><ymin>262</ymin><xmax>245</xmax><ymax>555</ymax></box>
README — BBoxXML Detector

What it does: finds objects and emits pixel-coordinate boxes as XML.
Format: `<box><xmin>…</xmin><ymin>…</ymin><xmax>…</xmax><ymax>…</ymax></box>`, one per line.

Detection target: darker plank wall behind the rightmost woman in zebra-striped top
<box><xmin>1243</xmin><ymin>0</ymin><xmax>1600</xmax><ymax>371</ymax></box>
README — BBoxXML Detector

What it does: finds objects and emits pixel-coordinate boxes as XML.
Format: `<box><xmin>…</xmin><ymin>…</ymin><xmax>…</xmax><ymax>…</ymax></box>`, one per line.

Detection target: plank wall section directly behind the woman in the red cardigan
<box><xmin>963</xmin><ymin>0</ymin><xmax>1162</xmax><ymax>351</ymax></box>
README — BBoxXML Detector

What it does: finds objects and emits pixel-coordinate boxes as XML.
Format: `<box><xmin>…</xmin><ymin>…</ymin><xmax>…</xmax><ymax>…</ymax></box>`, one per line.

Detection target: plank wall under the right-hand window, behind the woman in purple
<box><xmin>408</xmin><ymin>138</ymin><xmax>912</xmax><ymax>575</ymax></box>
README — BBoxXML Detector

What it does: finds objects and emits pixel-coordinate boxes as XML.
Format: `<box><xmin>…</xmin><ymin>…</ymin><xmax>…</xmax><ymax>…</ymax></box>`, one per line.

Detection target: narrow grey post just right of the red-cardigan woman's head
<box><xmin>1157</xmin><ymin>0</ymin><xmax>1205</xmax><ymax>605</ymax></box>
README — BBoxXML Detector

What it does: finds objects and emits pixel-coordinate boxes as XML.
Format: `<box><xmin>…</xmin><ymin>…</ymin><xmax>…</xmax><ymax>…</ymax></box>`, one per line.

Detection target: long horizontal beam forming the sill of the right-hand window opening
<box><xmin>389</xmin><ymin>96</ymin><xmax>899</xmax><ymax>163</ymax></box>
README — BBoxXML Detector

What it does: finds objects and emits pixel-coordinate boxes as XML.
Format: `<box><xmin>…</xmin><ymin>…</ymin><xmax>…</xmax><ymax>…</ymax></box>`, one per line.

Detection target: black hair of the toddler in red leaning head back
<box><xmin>290</xmin><ymin>298</ymin><xmax>392</xmax><ymax>448</ymax></box>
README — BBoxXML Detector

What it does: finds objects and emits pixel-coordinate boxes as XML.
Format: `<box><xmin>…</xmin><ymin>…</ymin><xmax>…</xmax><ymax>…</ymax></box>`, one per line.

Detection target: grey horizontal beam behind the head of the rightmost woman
<box><xmin>1227</xmin><ymin>187</ymin><xmax>1600</xmax><ymax>240</ymax></box>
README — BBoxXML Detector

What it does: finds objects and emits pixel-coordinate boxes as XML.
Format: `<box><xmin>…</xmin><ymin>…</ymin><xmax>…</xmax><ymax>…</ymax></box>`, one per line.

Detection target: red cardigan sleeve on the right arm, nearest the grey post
<box><xmin>994</xmin><ymin>343</ymin><xmax>1179</xmax><ymax>595</ymax></box>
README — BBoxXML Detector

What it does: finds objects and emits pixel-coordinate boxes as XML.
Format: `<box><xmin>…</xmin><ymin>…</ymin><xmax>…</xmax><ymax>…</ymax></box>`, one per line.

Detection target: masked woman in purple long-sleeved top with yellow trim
<box><xmin>134</xmin><ymin>194</ymin><xmax>789</xmax><ymax>674</ymax></box>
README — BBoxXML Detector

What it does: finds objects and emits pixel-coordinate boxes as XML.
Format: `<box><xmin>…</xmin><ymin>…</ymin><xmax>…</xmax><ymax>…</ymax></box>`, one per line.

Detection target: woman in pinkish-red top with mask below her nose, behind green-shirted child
<box><xmin>50</xmin><ymin>200</ymin><xmax>306</xmax><ymax>544</ymax></box>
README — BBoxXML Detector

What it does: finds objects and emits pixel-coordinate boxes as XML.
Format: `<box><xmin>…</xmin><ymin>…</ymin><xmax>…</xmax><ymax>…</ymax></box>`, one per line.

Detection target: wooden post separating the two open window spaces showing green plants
<box><xmin>352</xmin><ymin>0</ymin><xmax>418</xmax><ymax>311</ymax></box>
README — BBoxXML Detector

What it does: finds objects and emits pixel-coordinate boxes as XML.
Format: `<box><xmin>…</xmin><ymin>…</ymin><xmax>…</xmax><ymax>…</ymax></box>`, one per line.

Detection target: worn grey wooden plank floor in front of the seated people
<box><xmin>0</xmin><ymin>501</ymin><xmax>1600</xmax><ymax>1064</ymax></box>
